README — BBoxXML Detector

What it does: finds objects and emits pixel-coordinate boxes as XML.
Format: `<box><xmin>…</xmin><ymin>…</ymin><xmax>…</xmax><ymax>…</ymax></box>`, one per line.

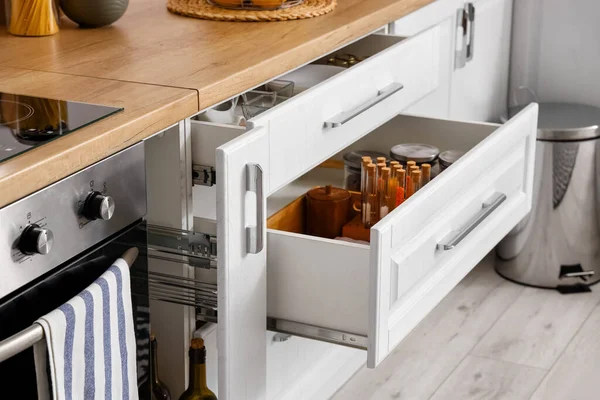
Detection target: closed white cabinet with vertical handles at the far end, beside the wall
<box><xmin>390</xmin><ymin>0</ymin><xmax>513</xmax><ymax>121</ymax></box>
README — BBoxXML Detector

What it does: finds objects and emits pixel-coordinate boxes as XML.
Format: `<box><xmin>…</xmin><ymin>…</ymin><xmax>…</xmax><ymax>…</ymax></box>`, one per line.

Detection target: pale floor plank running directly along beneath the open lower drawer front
<box><xmin>332</xmin><ymin>256</ymin><xmax>523</xmax><ymax>400</ymax></box>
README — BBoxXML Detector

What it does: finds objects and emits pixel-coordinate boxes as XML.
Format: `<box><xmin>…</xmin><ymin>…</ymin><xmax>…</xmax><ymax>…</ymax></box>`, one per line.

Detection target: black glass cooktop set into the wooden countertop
<box><xmin>0</xmin><ymin>92</ymin><xmax>123</xmax><ymax>162</ymax></box>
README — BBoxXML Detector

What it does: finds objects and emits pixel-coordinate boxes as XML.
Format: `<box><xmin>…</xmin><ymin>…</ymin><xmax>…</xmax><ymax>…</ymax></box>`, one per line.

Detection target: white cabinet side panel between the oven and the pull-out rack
<box><xmin>145</xmin><ymin>120</ymin><xmax>196</xmax><ymax>398</ymax></box>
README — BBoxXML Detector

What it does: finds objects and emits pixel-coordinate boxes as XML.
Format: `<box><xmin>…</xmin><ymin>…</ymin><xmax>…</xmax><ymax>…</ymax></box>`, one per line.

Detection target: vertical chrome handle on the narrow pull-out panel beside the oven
<box><xmin>246</xmin><ymin>164</ymin><xmax>265</xmax><ymax>254</ymax></box>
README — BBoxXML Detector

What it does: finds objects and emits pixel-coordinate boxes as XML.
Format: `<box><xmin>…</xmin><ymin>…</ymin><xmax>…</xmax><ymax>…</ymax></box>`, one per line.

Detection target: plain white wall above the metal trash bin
<box><xmin>510</xmin><ymin>0</ymin><xmax>600</xmax><ymax>107</ymax></box>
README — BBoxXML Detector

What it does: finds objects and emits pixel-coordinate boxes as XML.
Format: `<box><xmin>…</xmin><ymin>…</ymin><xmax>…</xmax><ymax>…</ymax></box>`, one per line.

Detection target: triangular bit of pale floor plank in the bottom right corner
<box><xmin>532</xmin><ymin>306</ymin><xmax>600</xmax><ymax>400</ymax></box>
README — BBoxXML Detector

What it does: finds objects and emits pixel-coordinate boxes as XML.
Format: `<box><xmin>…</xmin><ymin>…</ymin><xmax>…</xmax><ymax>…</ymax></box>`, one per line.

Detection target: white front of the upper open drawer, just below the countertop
<box><xmin>252</xmin><ymin>27</ymin><xmax>440</xmax><ymax>192</ymax></box>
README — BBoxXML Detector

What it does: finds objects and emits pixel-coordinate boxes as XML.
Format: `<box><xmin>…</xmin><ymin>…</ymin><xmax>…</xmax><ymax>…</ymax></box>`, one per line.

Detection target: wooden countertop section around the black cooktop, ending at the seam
<box><xmin>0</xmin><ymin>67</ymin><xmax>198</xmax><ymax>207</ymax></box>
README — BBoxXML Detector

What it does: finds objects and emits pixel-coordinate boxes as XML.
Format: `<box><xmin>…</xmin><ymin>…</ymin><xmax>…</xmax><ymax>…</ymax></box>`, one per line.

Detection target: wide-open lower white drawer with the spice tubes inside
<box><xmin>267</xmin><ymin>105</ymin><xmax>537</xmax><ymax>367</ymax></box>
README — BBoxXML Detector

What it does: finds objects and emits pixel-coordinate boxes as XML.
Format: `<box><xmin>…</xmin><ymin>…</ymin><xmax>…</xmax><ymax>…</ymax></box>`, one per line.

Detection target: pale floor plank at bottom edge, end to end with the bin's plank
<box><xmin>431</xmin><ymin>356</ymin><xmax>546</xmax><ymax>400</ymax></box>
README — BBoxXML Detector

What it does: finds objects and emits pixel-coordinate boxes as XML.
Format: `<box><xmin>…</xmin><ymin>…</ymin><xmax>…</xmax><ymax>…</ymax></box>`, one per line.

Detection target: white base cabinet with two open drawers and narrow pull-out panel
<box><xmin>149</xmin><ymin>10</ymin><xmax>537</xmax><ymax>400</ymax></box>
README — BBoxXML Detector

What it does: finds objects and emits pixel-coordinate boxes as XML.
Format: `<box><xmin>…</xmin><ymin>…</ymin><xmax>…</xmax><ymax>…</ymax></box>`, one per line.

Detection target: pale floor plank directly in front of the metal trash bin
<box><xmin>471</xmin><ymin>288</ymin><xmax>600</xmax><ymax>373</ymax></box>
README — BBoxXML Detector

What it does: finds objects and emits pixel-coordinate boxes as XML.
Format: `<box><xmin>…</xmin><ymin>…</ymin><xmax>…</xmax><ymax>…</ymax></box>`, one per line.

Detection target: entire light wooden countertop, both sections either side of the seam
<box><xmin>0</xmin><ymin>0</ymin><xmax>435</xmax><ymax>207</ymax></box>
